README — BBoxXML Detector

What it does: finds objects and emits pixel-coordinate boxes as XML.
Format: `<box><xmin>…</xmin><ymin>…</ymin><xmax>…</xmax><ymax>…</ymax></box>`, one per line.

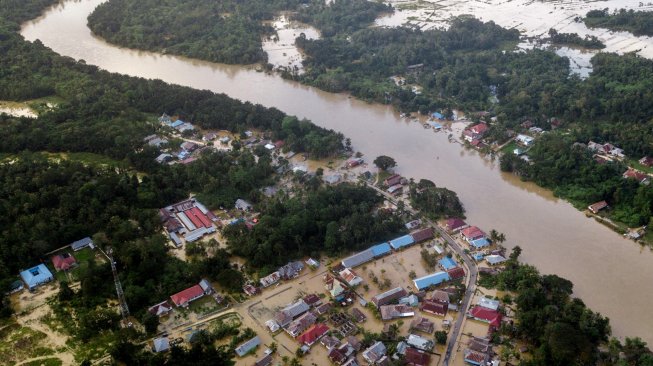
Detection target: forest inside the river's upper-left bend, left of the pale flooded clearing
<box><xmin>88</xmin><ymin>0</ymin><xmax>303</xmax><ymax>64</ymax></box>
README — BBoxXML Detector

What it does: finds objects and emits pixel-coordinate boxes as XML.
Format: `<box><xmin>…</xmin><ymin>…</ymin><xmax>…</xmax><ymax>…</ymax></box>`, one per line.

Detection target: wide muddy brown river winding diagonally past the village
<box><xmin>22</xmin><ymin>0</ymin><xmax>653</xmax><ymax>344</ymax></box>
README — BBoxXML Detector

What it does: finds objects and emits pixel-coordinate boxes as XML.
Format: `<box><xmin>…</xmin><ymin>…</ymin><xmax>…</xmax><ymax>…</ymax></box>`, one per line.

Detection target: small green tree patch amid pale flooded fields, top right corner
<box><xmin>583</xmin><ymin>9</ymin><xmax>653</xmax><ymax>36</ymax></box>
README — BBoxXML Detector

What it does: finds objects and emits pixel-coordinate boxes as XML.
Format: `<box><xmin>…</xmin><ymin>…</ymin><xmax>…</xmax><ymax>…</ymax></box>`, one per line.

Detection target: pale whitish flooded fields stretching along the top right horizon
<box><xmin>376</xmin><ymin>0</ymin><xmax>653</xmax><ymax>76</ymax></box>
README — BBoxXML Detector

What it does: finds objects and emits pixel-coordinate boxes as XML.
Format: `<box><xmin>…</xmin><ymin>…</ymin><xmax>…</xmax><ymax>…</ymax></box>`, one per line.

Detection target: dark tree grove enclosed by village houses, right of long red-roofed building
<box><xmin>224</xmin><ymin>184</ymin><xmax>404</xmax><ymax>272</ymax></box>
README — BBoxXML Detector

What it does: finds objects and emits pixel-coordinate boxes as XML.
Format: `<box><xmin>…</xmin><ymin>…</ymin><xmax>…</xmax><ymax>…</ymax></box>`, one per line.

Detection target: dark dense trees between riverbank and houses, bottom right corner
<box><xmin>480</xmin><ymin>247</ymin><xmax>653</xmax><ymax>366</ymax></box>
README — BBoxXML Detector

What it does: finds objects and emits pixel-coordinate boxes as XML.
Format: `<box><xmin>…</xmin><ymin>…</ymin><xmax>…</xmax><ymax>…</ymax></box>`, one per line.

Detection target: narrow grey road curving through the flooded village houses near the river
<box><xmin>365</xmin><ymin>182</ymin><xmax>478</xmax><ymax>366</ymax></box>
